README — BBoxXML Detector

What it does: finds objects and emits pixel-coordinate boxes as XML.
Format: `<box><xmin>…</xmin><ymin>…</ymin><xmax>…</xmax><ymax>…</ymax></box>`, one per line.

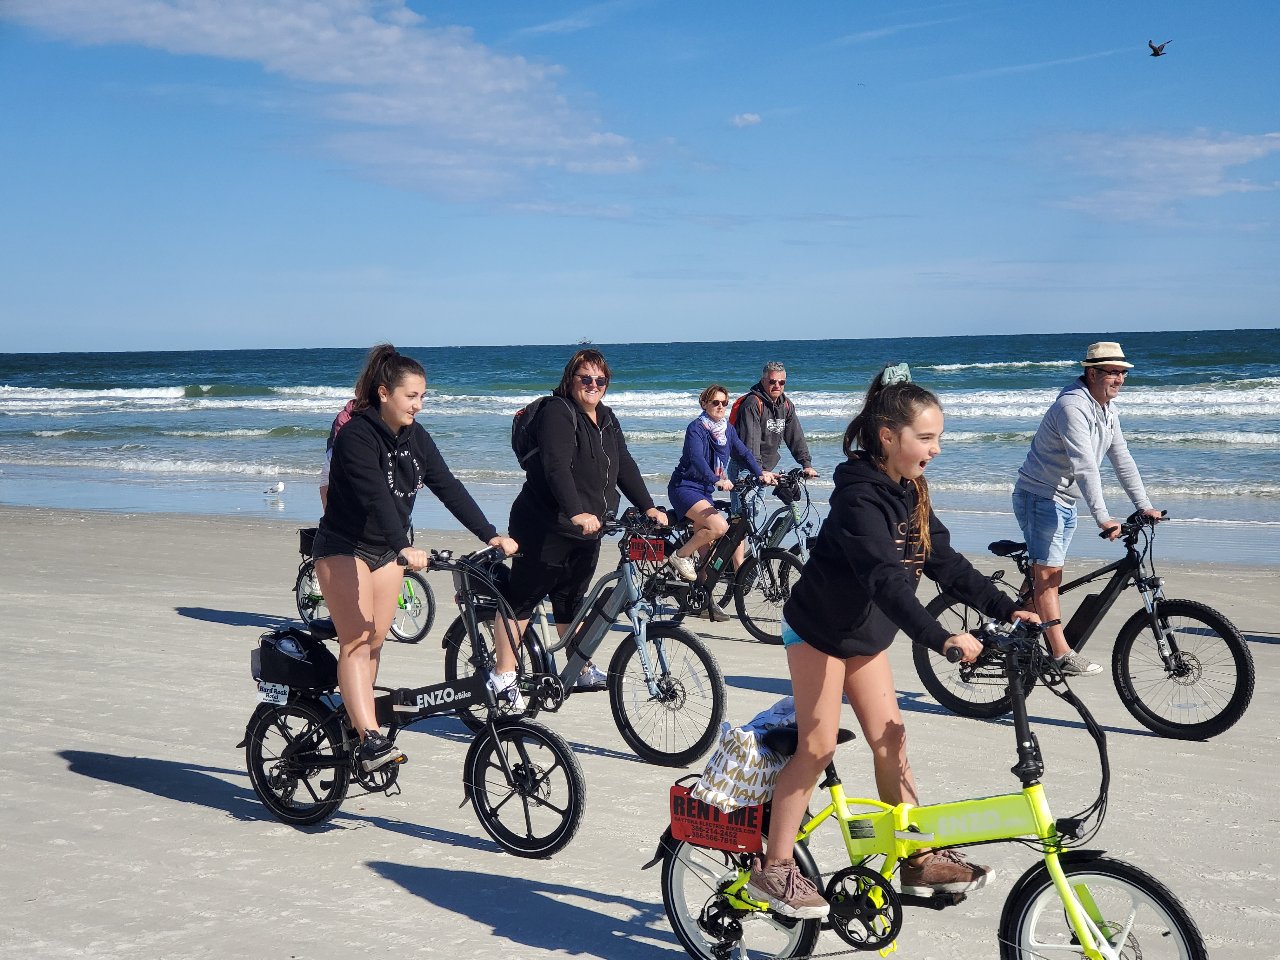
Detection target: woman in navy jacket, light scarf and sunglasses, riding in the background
<box><xmin>667</xmin><ymin>383</ymin><xmax>773</xmax><ymax>609</ymax></box>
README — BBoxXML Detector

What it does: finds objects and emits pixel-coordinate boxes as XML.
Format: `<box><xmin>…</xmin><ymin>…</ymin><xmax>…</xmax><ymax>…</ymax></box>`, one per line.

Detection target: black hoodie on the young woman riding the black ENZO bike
<box><xmin>320</xmin><ymin>407</ymin><xmax>498</xmax><ymax>550</ymax></box>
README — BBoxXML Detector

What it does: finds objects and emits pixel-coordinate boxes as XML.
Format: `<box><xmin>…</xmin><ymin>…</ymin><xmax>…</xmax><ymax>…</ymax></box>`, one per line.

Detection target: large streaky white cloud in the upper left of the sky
<box><xmin>0</xmin><ymin>0</ymin><xmax>640</xmax><ymax>197</ymax></box>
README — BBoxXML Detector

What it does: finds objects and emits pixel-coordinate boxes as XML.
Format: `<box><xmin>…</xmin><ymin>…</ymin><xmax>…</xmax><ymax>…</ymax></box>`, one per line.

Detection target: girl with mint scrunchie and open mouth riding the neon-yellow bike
<box><xmin>749</xmin><ymin>364</ymin><xmax>1037</xmax><ymax>918</ymax></box>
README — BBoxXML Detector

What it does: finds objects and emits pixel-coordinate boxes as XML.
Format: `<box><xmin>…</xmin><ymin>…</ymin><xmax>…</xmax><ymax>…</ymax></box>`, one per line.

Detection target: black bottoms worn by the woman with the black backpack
<box><xmin>502</xmin><ymin>532</ymin><xmax>600</xmax><ymax>625</ymax></box>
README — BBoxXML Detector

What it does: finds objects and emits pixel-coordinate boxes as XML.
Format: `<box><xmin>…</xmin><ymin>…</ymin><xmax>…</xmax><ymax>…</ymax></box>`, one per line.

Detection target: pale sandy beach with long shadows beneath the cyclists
<box><xmin>0</xmin><ymin>507</ymin><xmax>1280</xmax><ymax>960</ymax></box>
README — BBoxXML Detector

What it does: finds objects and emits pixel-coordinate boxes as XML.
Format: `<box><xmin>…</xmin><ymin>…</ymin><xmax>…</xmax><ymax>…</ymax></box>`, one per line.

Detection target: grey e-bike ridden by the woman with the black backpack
<box><xmin>443</xmin><ymin>509</ymin><xmax>726</xmax><ymax>767</ymax></box>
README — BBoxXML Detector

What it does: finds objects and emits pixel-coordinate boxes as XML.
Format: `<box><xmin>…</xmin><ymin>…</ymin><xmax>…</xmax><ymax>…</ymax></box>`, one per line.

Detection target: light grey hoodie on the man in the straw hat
<box><xmin>1014</xmin><ymin>376</ymin><xmax>1151</xmax><ymax>527</ymax></box>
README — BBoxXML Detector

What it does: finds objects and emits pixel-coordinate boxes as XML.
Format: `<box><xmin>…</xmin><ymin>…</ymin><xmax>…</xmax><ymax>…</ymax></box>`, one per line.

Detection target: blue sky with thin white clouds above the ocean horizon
<box><xmin>0</xmin><ymin>0</ymin><xmax>1280</xmax><ymax>352</ymax></box>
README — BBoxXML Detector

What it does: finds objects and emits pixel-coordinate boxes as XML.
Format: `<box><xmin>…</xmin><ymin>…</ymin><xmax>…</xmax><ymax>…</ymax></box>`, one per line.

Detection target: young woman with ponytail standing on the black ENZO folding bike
<box><xmin>312</xmin><ymin>343</ymin><xmax>516</xmax><ymax>771</ymax></box>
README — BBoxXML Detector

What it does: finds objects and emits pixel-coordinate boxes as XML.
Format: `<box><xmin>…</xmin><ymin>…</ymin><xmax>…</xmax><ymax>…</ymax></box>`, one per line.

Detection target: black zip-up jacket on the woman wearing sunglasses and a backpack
<box><xmin>511</xmin><ymin>398</ymin><xmax>653</xmax><ymax>540</ymax></box>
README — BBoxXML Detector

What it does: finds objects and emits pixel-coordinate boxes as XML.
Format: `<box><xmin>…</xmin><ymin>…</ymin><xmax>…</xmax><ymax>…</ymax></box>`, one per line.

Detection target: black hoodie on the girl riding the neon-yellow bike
<box><xmin>782</xmin><ymin>453</ymin><xmax>1016</xmax><ymax>658</ymax></box>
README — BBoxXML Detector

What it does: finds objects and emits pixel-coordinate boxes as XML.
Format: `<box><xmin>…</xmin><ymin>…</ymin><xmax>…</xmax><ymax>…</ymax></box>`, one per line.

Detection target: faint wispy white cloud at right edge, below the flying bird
<box><xmin>1056</xmin><ymin>132</ymin><xmax>1280</xmax><ymax>220</ymax></box>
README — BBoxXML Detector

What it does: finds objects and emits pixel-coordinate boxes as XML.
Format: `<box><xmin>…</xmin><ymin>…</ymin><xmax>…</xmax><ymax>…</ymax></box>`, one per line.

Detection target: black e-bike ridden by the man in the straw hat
<box><xmin>911</xmin><ymin>511</ymin><xmax>1253</xmax><ymax>740</ymax></box>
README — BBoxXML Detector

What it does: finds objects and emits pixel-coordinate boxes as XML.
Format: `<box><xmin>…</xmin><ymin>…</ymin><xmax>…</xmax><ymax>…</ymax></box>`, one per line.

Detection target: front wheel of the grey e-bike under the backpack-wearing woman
<box><xmin>609</xmin><ymin>621</ymin><xmax>726</xmax><ymax>767</ymax></box>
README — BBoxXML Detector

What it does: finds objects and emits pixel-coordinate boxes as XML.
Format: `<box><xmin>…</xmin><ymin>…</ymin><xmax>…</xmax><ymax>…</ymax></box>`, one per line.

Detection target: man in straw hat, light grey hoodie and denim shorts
<box><xmin>1014</xmin><ymin>340</ymin><xmax>1161</xmax><ymax>677</ymax></box>
